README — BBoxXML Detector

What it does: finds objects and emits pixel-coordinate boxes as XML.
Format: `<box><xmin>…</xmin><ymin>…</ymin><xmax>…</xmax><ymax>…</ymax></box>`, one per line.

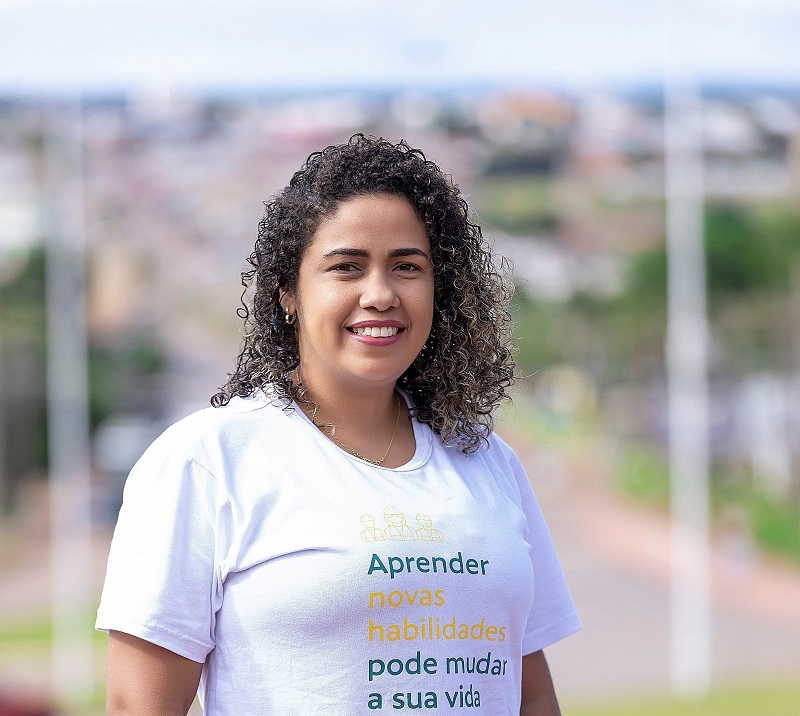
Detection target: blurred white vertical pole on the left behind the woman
<box><xmin>44</xmin><ymin>102</ymin><xmax>93</xmax><ymax>702</ymax></box>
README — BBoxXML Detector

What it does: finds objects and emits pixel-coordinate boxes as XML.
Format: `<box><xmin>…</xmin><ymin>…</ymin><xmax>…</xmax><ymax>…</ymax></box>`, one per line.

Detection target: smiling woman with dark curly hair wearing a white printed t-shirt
<box><xmin>97</xmin><ymin>135</ymin><xmax>579</xmax><ymax>716</ymax></box>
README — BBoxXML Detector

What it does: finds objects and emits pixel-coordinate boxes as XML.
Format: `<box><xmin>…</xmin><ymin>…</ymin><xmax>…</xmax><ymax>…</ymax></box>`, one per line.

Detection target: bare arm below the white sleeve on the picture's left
<box><xmin>107</xmin><ymin>631</ymin><xmax>203</xmax><ymax>716</ymax></box>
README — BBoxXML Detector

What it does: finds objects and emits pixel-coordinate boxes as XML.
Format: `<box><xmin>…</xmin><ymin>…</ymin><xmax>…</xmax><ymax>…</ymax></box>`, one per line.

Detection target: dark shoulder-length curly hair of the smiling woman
<box><xmin>211</xmin><ymin>134</ymin><xmax>514</xmax><ymax>454</ymax></box>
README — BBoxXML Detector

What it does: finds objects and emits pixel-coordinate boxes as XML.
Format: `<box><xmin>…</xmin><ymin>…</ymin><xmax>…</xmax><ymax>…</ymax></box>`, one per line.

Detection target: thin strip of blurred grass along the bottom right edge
<box><xmin>562</xmin><ymin>682</ymin><xmax>800</xmax><ymax>716</ymax></box>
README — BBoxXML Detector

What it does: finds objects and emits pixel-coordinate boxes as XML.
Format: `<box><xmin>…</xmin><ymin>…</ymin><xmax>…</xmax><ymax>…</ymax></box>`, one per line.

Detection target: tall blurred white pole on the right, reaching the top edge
<box><xmin>664</xmin><ymin>0</ymin><xmax>711</xmax><ymax>697</ymax></box>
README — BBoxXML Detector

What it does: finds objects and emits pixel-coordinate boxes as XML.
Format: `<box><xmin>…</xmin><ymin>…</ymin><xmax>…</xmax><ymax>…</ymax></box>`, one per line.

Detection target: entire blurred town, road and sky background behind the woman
<box><xmin>0</xmin><ymin>0</ymin><xmax>800</xmax><ymax>716</ymax></box>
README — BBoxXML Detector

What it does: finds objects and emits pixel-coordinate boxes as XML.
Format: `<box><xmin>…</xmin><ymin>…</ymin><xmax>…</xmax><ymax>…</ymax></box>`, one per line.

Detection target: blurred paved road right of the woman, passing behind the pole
<box><xmin>506</xmin><ymin>434</ymin><xmax>800</xmax><ymax>700</ymax></box>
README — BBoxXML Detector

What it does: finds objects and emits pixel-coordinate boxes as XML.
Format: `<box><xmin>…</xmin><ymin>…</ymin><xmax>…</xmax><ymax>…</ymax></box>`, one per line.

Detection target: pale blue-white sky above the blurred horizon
<box><xmin>0</xmin><ymin>0</ymin><xmax>800</xmax><ymax>94</ymax></box>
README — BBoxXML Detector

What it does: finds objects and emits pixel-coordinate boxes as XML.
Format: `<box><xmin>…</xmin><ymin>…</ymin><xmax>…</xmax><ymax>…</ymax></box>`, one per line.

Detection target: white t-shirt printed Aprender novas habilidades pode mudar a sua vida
<box><xmin>97</xmin><ymin>396</ymin><xmax>580</xmax><ymax>716</ymax></box>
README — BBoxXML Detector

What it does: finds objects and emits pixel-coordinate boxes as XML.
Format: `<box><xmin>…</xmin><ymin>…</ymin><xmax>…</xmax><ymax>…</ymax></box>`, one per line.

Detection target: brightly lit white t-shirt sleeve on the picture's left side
<box><xmin>96</xmin><ymin>431</ymin><xmax>219</xmax><ymax>663</ymax></box>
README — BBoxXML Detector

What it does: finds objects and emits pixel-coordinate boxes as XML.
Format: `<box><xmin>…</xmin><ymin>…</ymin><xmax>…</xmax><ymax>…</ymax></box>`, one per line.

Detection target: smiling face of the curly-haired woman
<box><xmin>281</xmin><ymin>195</ymin><xmax>434</xmax><ymax>392</ymax></box>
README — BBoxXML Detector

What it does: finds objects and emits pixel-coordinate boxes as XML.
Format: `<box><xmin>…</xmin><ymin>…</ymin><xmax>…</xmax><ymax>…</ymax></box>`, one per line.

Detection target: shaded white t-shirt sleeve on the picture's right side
<box><xmin>509</xmin><ymin>448</ymin><xmax>581</xmax><ymax>654</ymax></box>
